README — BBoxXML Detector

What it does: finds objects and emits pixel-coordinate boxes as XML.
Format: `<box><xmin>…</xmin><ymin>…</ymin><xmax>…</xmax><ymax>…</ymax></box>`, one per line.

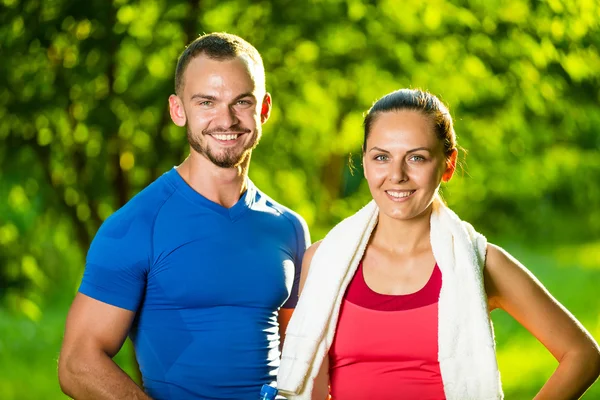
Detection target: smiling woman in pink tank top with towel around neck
<box><xmin>278</xmin><ymin>89</ymin><xmax>600</xmax><ymax>400</ymax></box>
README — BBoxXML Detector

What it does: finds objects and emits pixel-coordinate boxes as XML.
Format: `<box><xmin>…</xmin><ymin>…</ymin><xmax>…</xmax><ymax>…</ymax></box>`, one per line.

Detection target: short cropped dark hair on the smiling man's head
<box><xmin>175</xmin><ymin>32</ymin><xmax>265</xmax><ymax>95</ymax></box>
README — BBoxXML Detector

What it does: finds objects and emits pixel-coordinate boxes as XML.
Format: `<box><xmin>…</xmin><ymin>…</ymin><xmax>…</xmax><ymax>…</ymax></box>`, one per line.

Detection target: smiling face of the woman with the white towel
<box><xmin>363</xmin><ymin>110</ymin><xmax>457</xmax><ymax>220</ymax></box>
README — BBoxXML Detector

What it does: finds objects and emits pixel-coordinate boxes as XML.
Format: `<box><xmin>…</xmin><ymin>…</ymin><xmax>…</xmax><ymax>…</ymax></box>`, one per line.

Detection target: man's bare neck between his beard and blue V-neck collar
<box><xmin>177</xmin><ymin>151</ymin><xmax>250</xmax><ymax>208</ymax></box>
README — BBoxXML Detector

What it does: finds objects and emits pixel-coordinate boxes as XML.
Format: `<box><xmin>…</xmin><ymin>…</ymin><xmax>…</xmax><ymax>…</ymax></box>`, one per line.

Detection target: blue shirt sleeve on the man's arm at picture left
<box><xmin>79</xmin><ymin>209</ymin><xmax>151</xmax><ymax>311</ymax></box>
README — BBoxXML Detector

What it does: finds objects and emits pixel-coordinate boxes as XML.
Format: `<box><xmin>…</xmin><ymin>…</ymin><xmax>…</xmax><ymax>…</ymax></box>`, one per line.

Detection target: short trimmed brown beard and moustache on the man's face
<box><xmin>187</xmin><ymin>125</ymin><xmax>262</xmax><ymax>168</ymax></box>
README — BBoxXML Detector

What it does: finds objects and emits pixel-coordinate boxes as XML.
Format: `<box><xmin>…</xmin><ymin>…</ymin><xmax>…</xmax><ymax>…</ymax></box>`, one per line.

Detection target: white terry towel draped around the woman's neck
<box><xmin>277</xmin><ymin>198</ymin><xmax>503</xmax><ymax>400</ymax></box>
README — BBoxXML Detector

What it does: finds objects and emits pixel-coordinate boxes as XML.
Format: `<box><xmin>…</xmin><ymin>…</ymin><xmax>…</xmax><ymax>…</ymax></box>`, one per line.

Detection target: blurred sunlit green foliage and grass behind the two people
<box><xmin>0</xmin><ymin>0</ymin><xmax>600</xmax><ymax>399</ymax></box>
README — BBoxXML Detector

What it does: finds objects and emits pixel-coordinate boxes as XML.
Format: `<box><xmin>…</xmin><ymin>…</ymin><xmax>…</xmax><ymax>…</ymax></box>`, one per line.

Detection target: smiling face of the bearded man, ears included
<box><xmin>170</xmin><ymin>55</ymin><xmax>271</xmax><ymax>168</ymax></box>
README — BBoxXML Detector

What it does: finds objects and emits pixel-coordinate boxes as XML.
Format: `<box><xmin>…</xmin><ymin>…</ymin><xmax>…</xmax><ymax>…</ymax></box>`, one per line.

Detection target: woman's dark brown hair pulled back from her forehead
<box><xmin>363</xmin><ymin>89</ymin><xmax>457</xmax><ymax>157</ymax></box>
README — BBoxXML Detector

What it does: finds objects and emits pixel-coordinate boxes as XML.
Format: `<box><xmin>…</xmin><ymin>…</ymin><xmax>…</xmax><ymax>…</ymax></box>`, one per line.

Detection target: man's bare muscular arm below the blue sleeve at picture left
<box><xmin>58</xmin><ymin>293</ymin><xmax>150</xmax><ymax>400</ymax></box>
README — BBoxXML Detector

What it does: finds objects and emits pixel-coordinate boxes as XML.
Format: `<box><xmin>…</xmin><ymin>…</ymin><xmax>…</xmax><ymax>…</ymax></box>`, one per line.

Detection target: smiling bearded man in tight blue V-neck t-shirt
<box><xmin>59</xmin><ymin>33</ymin><xmax>309</xmax><ymax>400</ymax></box>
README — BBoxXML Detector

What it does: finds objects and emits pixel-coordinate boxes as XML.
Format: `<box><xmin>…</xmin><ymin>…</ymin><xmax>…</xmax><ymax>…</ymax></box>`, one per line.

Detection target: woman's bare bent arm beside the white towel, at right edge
<box><xmin>484</xmin><ymin>244</ymin><xmax>600</xmax><ymax>400</ymax></box>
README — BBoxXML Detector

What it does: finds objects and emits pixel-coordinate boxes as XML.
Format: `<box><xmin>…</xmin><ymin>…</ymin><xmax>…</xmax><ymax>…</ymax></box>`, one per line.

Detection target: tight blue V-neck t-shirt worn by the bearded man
<box><xmin>79</xmin><ymin>168</ymin><xmax>310</xmax><ymax>400</ymax></box>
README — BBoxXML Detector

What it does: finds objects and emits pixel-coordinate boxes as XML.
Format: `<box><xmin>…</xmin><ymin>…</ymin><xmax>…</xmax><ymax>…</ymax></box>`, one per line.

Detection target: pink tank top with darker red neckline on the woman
<box><xmin>329</xmin><ymin>262</ymin><xmax>446</xmax><ymax>400</ymax></box>
